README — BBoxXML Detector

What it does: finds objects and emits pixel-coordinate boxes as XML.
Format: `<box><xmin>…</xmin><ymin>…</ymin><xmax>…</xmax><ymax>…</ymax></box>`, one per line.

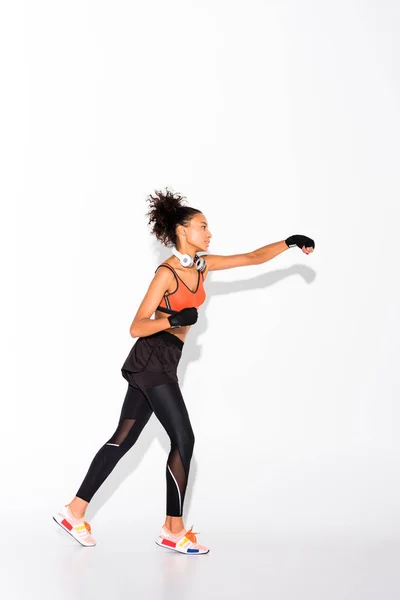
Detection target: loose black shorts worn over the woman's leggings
<box><xmin>121</xmin><ymin>331</ymin><xmax>184</xmax><ymax>388</ymax></box>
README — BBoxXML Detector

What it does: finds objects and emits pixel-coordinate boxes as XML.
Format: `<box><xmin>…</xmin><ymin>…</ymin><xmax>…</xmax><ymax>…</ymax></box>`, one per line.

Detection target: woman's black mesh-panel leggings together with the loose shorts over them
<box><xmin>76</xmin><ymin>331</ymin><xmax>195</xmax><ymax>517</ymax></box>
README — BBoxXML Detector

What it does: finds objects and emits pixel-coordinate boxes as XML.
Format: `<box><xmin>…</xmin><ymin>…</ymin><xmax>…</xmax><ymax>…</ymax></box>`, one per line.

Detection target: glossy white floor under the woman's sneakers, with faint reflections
<box><xmin>0</xmin><ymin>516</ymin><xmax>400</xmax><ymax>600</ymax></box>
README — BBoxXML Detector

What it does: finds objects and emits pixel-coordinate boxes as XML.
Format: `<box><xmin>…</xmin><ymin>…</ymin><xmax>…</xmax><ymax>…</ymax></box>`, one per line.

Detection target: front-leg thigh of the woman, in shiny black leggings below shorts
<box><xmin>145</xmin><ymin>382</ymin><xmax>194</xmax><ymax>441</ymax></box>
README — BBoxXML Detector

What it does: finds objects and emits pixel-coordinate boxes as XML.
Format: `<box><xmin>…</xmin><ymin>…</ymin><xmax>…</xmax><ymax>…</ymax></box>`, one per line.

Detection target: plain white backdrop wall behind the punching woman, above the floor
<box><xmin>0</xmin><ymin>0</ymin><xmax>400</xmax><ymax>596</ymax></box>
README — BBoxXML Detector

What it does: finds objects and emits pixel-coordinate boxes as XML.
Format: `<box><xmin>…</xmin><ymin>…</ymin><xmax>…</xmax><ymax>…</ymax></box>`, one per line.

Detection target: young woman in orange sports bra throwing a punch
<box><xmin>53</xmin><ymin>190</ymin><xmax>315</xmax><ymax>554</ymax></box>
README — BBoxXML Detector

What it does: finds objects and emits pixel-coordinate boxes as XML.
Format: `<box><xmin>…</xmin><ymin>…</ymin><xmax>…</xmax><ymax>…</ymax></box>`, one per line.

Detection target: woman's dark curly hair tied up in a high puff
<box><xmin>146</xmin><ymin>188</ymin><xmax>201</xmax><ymax>248</ymax></box>
